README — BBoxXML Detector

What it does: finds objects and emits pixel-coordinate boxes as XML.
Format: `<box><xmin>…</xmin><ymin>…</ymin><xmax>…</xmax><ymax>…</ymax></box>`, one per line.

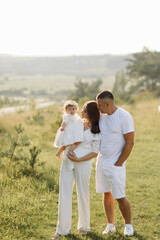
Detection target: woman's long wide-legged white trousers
<box><xmin>57</xmin><ymin>160</ymin><xmax>92</xmax><ymax>235</ymax></box>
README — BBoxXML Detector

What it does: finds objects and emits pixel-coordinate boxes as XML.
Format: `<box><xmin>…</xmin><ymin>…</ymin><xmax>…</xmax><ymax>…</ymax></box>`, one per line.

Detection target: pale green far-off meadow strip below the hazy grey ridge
<box><xmin>0</xmin><ymin>75</ymin><xmax>114</xmax><ymax>93</ymax></box>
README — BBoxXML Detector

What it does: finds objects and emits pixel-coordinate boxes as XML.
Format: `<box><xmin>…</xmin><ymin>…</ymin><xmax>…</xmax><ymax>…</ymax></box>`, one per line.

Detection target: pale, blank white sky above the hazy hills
<box><xmin>0</xmin><ymin>0</ymin><xmax>160</xmax><ymax>56</ymax></box>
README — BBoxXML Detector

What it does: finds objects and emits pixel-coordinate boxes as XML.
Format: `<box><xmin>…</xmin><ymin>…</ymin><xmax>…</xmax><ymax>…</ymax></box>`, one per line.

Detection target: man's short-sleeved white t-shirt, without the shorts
<box><xmin>98</xmin><ymin>108</ymin><xmax>134</xmax><ymax>168</ymax></box>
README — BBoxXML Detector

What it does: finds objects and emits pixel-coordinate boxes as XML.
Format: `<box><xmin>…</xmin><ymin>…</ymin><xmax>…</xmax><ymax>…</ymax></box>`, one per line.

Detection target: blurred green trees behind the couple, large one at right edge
<box><xmin>69</xmin><ymin>48</ymin><xmax>160</xmax><ymax>102</ymax></box>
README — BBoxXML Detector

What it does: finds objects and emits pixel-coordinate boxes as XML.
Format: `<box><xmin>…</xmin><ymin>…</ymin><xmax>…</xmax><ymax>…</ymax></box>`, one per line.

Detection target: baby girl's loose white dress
<box><xmin>54</xmin><ymin>113</ymin><xmax>84</xmax><ymax>147</ymax></box>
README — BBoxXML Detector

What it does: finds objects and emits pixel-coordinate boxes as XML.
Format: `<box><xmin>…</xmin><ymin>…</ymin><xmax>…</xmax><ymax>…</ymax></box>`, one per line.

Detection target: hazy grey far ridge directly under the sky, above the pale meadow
<box><xmin>0</xmin><ymin>55</ymin><xmax>128</xmax><ymax>78</ymax></box>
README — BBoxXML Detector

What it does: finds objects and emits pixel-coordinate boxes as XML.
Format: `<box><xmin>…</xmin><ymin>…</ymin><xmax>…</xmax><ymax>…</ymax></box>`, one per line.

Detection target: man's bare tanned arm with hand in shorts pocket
<box><xmin>115</xmin><ymin>132</ymin><xmax>134</xmax><ymax>166</ymax></box>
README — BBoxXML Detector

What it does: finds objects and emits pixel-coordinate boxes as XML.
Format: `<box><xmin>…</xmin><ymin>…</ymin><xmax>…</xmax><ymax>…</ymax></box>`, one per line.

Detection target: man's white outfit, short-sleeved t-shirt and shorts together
<box><xmin>96</xmin><ymin>108</ymin><xmax>134</xmax><ymax>198</ymax></box>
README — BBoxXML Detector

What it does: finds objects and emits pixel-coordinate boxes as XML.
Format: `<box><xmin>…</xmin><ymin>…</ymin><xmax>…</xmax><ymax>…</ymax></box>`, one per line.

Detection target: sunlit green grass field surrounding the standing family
<box><xmin>0</xmin><ymin>99</ymin><xmax>160</xmax><ymax>240</ymax></box>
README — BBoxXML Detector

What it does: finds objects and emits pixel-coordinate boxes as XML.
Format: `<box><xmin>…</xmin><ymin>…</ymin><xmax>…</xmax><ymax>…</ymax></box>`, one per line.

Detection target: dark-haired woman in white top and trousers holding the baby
<box><xmin>53</xmin><ymin>101</ymin><xmax>100</xmax><ymax>239</ymax></box>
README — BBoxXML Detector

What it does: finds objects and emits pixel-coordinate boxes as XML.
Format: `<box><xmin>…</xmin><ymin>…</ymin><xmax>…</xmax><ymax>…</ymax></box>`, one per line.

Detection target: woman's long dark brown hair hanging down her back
<box><xmin>85</xmin><ymin>101</ymin><xmax>100</xmax><ymax>133</ymax></box>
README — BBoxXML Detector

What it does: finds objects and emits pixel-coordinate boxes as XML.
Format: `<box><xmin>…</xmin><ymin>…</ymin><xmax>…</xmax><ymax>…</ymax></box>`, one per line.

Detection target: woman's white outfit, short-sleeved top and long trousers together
<box><xmin>57</xmin><ymin>129</ymin><xmax>100</xmax><ymax>235</ymax></box>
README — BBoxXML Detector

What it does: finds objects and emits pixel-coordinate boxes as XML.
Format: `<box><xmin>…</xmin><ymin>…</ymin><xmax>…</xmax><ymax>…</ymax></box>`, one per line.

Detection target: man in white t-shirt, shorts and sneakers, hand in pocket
<box><xmin>96</xmin><ymin>91</ymin><xmax>134</xmax><ymax>236</ymax></box>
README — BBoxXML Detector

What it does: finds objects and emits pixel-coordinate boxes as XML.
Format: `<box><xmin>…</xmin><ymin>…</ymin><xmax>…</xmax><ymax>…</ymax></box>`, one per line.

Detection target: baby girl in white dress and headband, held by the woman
<box><xmin>54</xmin><ymin>100</ymin><xmax>84</xmax><ymax>161</ymax></box>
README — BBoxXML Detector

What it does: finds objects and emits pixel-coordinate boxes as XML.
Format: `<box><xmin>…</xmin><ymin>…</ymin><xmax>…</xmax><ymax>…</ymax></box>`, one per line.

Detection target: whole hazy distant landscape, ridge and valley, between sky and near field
<box><xmin>0</xmin><ymin>55</ymin><xmax>128</xmax><ymax>105</ymax></box>
